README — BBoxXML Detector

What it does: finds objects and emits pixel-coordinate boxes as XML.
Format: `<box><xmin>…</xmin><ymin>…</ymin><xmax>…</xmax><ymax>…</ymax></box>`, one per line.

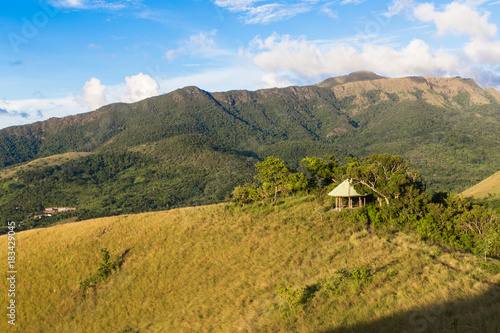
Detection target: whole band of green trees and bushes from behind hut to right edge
<box><xmin>231</xmin><ymin>154</ymin><xmax>500</xmax><ymax>258</ymax></box>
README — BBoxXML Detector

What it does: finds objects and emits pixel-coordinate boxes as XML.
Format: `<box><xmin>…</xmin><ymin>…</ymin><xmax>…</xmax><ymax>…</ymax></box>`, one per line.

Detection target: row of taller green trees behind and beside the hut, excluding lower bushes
<box><xmin>232</xmin><ymin>154</ymin><xmax>425</xmax><ymax>206</ymax></box>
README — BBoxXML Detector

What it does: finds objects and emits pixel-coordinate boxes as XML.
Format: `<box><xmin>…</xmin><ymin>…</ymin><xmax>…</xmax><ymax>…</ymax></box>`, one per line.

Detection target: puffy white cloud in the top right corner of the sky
<box><xmin>413</xmin><ymin>1</ymin><xmax>497</xmax><ymax>38</ymax></box>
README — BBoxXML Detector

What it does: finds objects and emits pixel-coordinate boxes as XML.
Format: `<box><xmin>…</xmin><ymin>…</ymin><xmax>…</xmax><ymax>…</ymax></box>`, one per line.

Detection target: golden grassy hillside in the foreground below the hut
<box><xmin>0</xmin><ymin>198</ymin><xmax>500</xmax><ymax>333</ymax></box>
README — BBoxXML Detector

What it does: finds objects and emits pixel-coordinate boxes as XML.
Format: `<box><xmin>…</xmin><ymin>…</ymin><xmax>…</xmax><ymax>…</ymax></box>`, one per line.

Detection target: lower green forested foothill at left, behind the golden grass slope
<box><xmin>0</xmin><ymin>137</ymin><xmax>253</xmax><ymax>232</ymax></box>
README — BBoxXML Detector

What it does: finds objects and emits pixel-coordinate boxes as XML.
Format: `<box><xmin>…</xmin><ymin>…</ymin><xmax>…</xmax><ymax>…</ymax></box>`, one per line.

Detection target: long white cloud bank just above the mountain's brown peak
<box><xmin>249</xmin><ymin>34</ymin><xmax>459</xmax><ymax>86</ymax></box>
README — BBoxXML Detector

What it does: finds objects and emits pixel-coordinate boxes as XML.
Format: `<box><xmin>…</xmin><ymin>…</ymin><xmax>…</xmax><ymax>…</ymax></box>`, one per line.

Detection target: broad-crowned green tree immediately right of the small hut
<box><xmin>346</xmin><ymin>154</ymin><xmax>424</xmax><ymax>206</ymax></box>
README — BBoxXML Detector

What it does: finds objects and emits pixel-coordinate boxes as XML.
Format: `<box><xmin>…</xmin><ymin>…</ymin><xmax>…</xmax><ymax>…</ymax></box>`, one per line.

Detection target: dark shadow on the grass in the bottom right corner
<box><xmin>316</xmin><ymin>284</ymin><xmax>500</xmax><ymax>333</ymax></box>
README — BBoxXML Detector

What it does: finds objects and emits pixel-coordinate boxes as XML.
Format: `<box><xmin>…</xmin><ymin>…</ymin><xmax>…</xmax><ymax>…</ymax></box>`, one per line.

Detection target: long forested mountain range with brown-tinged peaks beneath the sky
<box><xmin>0</xmin><ymin>72</ymin><xmax>500</xmax><ymax>223</ymax></box>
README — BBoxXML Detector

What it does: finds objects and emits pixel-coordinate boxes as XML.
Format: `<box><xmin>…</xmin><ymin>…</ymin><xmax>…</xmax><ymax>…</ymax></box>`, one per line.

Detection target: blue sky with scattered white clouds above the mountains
<box><xmin>0</xmin><ymin>0</ymin><xmax>500</xmax><ymax>128</ymax></box>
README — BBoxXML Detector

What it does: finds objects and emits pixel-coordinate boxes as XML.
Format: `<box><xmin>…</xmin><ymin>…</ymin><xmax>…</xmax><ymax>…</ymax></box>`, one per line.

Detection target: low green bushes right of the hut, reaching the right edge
<box><xmin>350</xmin><ymin>189</ymin><xmax>500</xmax><ymax>259</ymax></box>
